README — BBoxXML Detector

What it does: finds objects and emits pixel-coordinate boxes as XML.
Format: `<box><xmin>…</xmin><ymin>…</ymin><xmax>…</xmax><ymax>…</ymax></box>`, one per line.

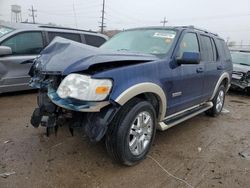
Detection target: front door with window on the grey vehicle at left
<box><xmin>0</xmin><ymin>31</ymin><xmax>44</xmax><ymax>92</ymax></box>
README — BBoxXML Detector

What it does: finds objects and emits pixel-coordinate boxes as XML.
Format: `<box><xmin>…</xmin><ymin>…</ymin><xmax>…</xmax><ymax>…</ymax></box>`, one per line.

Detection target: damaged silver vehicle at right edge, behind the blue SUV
<box><xmin>231</xmin><ymin>49</ymin><xmax>250</xmax><ymax>95</ymax></box>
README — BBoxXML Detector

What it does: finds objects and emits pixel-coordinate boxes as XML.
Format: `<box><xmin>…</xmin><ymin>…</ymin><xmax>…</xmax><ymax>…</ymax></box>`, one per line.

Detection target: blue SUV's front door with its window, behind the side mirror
<box><xmin>167</xmin><ymin>32</ymin><xmax>204</xmax><ymax>115</ymax></box>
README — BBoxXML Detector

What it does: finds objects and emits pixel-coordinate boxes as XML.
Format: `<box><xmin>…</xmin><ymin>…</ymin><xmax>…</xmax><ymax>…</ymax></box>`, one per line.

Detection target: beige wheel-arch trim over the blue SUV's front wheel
<box><xmin>115</xmin><ymin>82</ymin><xmax>167</xmax><ymax>121</ymax></box>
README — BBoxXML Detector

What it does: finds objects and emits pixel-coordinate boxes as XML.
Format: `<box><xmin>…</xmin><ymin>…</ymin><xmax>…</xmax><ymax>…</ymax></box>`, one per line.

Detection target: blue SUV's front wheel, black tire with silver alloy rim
<box><xmin>106</xmin><ymin>99</ymin><xmax>156</xmax><ymax>166</ymax></box>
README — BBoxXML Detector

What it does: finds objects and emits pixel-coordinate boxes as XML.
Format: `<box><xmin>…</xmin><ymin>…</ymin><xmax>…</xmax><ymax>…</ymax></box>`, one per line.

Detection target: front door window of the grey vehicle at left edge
<box><xmin>1</xmin><ymin>31</ymin><xmax>44</xmax><ymax>55</ymax></box>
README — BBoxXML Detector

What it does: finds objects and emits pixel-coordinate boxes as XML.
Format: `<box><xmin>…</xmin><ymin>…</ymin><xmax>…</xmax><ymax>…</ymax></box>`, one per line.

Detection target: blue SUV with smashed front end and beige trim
<box><xmin>30</xmin><ymin>26</ymin><xmax>232</xmax><ymax>166</ymax></box>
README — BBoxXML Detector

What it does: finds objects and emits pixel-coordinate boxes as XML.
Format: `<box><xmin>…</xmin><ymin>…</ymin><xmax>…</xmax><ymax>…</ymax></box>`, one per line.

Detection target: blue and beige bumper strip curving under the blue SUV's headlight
<box><xmin>48</xmin><ymin>89</ymin><xmax>110</xmax><ymax>112</ymax></box>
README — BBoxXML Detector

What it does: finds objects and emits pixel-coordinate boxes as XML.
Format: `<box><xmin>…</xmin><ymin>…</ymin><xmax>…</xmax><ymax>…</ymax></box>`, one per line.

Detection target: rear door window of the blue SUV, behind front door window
<box><xmin>201</xmin><ymin>35</ymin><xmax>214</xmax><ymax>62</ymax></box>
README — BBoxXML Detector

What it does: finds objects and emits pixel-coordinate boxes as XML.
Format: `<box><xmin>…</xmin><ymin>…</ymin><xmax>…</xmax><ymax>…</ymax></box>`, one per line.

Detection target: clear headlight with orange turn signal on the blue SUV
<box><xmin>57</xmin><ymin>74</ymin><xmax>112</xmax><ymax>101</ymax></box>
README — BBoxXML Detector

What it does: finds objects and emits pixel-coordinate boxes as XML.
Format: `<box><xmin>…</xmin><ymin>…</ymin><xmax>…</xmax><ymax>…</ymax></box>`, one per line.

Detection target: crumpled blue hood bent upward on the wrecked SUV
<box><xmin>36</xmin><ymin>37</ymin><xmax>158</xmax><ymax>75</ymax></box>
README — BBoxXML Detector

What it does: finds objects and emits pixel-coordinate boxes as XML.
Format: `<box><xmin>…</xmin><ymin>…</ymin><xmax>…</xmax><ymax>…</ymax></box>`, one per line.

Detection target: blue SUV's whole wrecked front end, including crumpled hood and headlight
<box><xmin>29</xmin><ymin>37</ymin><xmax>157</xmax><ymax>141</ymax></box>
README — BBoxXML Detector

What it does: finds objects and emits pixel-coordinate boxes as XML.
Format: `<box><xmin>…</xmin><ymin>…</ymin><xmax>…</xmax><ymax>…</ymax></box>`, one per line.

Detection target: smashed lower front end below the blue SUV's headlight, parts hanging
<box><xmin>30</xmin><ymin>71</ymin><xmax>119</xmax><ymax>142</ymax></box>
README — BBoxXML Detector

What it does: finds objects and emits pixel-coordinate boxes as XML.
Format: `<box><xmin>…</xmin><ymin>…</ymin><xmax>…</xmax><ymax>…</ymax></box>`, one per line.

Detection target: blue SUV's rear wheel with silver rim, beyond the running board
<box><xmin>206</xmin><ymin>85</ymin><xmax>226</xmax><ymax>117</ymax></box>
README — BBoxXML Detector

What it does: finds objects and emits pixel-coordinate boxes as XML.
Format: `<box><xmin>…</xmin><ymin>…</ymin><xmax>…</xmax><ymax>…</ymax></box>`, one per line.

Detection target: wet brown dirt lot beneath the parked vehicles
<box><xmin>0</xmin><ymin>92</ymin><xmax>250</xmax><ymax>188</ymax></box>
